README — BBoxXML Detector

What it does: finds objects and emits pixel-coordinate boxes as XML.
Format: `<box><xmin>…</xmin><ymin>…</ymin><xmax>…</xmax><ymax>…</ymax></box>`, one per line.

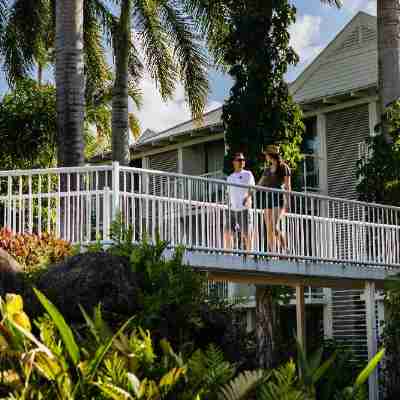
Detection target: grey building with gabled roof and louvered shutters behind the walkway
<box><xmin>123</xmin><ymin>12</ymin><xmax>383</xmax><ymax>357</ymax></box>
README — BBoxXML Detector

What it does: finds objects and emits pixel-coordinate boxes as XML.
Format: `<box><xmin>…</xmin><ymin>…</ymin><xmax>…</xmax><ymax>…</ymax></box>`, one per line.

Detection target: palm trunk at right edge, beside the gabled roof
<box><xmin>377</xmin><ymin>0</ymin><xmax>400</xmax><ymax>134</ymax></box>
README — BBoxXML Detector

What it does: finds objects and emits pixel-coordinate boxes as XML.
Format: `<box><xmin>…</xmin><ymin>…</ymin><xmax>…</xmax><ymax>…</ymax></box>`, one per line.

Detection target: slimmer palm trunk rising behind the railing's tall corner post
<box><xmin>112</xmin><ymin>0</ymin><xmax>131</xmax><ymax>165</ymax></box>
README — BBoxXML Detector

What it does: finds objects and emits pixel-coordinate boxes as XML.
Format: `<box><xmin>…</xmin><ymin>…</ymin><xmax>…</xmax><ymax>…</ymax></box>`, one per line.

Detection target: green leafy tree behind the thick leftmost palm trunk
<box><xmin>0</xmin><ymin>79</ymin><xmax>111</xmax><ymax>169</ymax></box>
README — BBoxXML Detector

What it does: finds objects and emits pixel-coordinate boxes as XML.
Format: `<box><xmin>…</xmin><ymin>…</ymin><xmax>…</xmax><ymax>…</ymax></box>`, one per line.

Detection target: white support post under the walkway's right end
<box><xmin>365</xmin><ymin>282</ymin><xmax>379</xmax><ymax>400</ymax></box>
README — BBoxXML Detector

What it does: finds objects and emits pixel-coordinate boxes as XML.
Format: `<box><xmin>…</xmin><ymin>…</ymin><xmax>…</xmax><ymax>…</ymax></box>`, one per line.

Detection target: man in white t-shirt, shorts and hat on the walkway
<box><xmin>224</xmin><ymin>153</ymin><xmax>255</xmax><ymax>250</ymax></box>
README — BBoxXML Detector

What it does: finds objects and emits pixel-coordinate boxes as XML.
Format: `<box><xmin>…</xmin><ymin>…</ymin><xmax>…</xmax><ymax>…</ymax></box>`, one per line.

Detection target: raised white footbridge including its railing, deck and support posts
<box><xmin>0</xmin><ymin>163</ymin><xmax>400</xmax><ymax>398</ymax></box>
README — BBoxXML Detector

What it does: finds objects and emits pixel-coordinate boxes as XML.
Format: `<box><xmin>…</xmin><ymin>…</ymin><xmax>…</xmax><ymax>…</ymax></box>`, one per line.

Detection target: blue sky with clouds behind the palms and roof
<box><xmin>0</xmin><ymin>0</ymin><xmax>376</xmax><ymax>131</ymax></box>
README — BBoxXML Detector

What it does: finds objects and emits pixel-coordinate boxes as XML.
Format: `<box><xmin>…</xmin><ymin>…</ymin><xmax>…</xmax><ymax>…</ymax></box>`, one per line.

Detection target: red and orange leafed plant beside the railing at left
<box><xmin>0</xmin><ymin>228</ymin><xmax>72</xmax><ymax>271</ymax></box>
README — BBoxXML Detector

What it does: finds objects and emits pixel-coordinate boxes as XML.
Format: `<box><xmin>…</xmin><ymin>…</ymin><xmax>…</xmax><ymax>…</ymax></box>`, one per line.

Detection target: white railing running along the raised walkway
<box><xmin>0</xmin><ymin>163</ymin><xmax>400</xmax><ymax>267</ymax></box>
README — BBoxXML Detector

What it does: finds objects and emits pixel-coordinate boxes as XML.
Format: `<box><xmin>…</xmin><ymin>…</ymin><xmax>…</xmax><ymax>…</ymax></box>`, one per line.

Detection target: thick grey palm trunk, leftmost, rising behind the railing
<box><xmin>56</xmin><ymin>0</ymin><xmax>85</xmax><ymax>166</ymax></box>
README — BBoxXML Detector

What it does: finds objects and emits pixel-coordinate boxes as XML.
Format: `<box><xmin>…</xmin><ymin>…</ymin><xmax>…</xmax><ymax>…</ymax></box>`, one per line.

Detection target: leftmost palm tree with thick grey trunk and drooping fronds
<box><xmin>0</xmin><ymin>0</ymin><xmax>116</xmax><ymax>165</ymax></box>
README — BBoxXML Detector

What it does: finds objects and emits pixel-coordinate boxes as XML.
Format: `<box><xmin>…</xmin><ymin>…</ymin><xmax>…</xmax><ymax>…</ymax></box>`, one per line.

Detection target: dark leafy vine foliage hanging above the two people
<box><xmin>222</xmin><ymin>0</ymin><xmax>304</xmax><ymax>174</ymax></box>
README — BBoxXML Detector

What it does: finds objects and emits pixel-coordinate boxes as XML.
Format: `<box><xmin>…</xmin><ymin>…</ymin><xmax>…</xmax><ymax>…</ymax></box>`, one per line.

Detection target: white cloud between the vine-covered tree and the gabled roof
<box><xmin>289</xmin><ymin>14</ymin><xmax>322</xmax><ymax>64</ymax></box>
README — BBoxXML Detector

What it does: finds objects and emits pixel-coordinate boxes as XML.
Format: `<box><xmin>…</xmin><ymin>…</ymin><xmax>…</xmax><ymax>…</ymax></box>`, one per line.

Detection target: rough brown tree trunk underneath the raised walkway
<box><xmin>256</xmin><ymin>286</ymin><xmax>281</xmax><ymax>369</ymax></box>
